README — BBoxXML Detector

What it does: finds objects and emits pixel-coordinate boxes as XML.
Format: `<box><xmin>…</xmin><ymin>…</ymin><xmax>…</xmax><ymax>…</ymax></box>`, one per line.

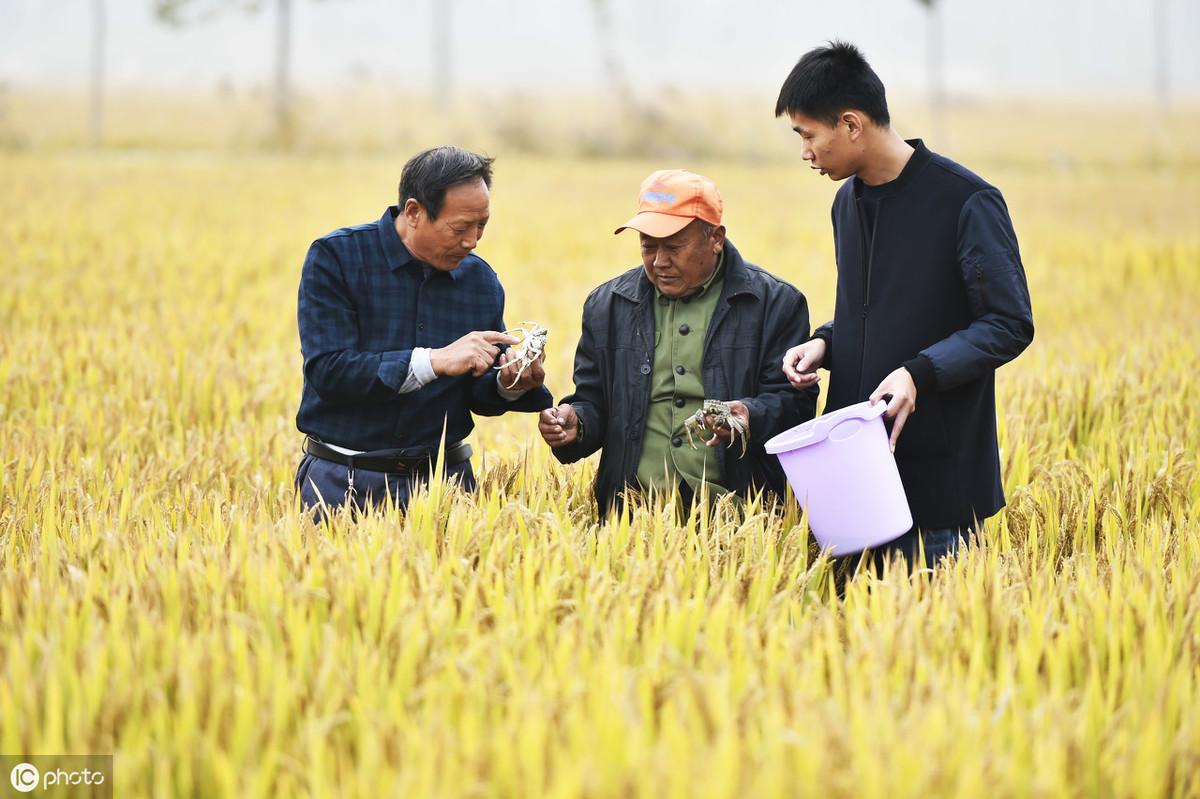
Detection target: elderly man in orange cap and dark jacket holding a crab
<box><xmin>539</xmin><ymin>169</ymin><xmax>817</xmax><ymax>510</ymax></box>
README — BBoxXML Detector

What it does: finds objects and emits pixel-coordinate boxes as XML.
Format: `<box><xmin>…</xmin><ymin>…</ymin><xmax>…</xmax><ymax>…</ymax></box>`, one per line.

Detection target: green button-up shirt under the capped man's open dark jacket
<box><xmin>637</xmin><ymin>252</ymin><xmax>726</xmax><ymax>494</ymax></box>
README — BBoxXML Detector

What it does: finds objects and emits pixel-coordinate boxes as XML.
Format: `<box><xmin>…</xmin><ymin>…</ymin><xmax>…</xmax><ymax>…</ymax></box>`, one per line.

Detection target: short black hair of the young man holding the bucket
<box><xmin>775</xmin><ymin>40</ymin><xmax>892</xmax><ymax>127</ymax></box>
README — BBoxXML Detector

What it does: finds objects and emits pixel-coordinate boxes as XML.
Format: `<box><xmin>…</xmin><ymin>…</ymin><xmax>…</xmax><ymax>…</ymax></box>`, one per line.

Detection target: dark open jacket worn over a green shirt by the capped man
<box><xmin>553</xmin><ymin>240</ymin><xmax>817</xmax><ymax>509</ymax></box>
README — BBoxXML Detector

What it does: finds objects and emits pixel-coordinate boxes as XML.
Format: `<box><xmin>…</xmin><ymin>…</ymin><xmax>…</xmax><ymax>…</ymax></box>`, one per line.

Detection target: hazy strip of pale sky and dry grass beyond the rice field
<box><xmin>0</xmin><ymin>0</ymin><xmax>1200</xmax><ymax>162</ymax></box>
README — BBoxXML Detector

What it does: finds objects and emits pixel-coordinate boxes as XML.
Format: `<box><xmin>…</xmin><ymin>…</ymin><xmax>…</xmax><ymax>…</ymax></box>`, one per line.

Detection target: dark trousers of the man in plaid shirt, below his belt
<box><xmin>295</xmin><ymin>455</ymin><xmax>475</xmax><ymax>519</ymax></box>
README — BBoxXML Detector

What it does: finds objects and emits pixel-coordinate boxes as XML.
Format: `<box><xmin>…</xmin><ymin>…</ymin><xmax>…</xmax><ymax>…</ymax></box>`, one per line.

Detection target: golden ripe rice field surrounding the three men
<box><xmin>7</xmin><ymin>115</ymin><xmax>1200</xmax><ymax>798</ymax></box>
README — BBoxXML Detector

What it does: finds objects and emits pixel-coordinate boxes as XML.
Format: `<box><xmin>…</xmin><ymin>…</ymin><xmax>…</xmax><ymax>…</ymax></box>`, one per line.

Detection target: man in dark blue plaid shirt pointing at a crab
<box><xmin>296</xmin><ymin>146</ymin><xmax>551</xmax><ymax>513</ymax></box>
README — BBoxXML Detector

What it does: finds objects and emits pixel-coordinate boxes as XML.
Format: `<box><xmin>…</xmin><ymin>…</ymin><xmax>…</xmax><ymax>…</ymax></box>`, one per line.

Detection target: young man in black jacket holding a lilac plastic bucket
<box><xmin>775</xmin><ymin>42</ymin><xmax>1033</xmax><ymax>565</ymax></box>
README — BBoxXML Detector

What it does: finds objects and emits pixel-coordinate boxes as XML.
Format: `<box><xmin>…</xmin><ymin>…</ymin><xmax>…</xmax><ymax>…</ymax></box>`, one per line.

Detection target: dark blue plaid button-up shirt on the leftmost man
<box><xmin>296</xmin><ymin>206</ymin><xmax>551</xmax><ymax>456</ymax></box>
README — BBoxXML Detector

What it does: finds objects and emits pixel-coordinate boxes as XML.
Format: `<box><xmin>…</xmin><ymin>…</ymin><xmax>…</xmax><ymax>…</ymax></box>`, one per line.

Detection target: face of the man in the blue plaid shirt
<box><xmin>402</xmin><ymin>180</ymin><xmax>491</xmax><ymax>272</ymax></box>
